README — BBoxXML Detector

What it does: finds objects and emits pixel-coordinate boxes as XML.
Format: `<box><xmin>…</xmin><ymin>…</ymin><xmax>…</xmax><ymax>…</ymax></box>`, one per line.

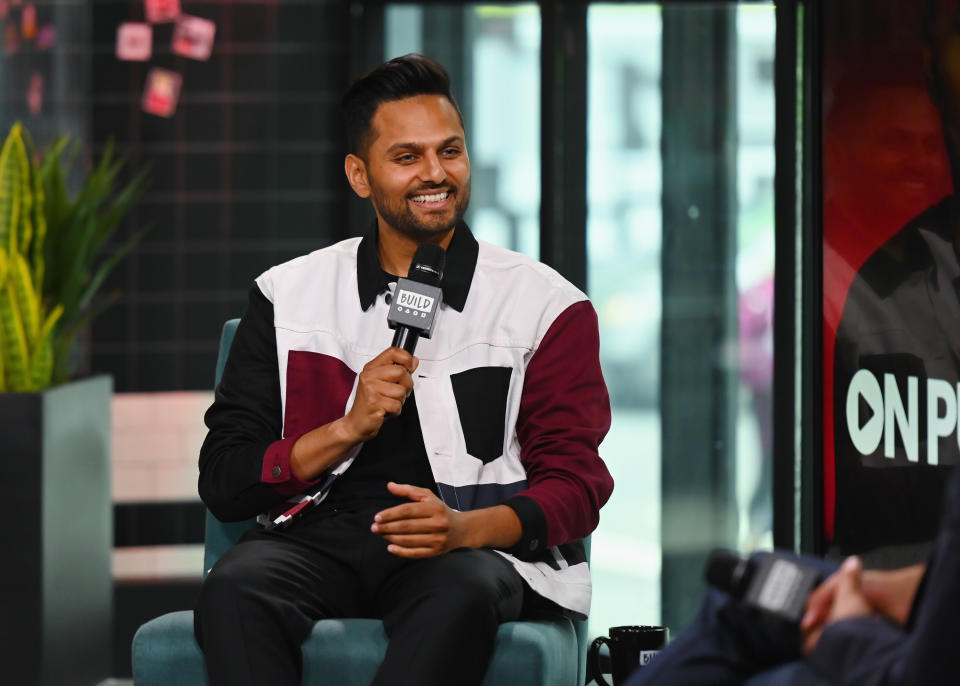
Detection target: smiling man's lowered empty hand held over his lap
<box><xmin>370</xmin><ymin>481</ymin><xmax>467</xmax><ymax>558</ymax></box>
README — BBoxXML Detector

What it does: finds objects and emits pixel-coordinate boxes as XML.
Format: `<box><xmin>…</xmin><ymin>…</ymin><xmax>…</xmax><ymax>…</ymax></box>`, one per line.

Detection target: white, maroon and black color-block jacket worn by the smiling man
<box><xmin>199</xmin><ymin>224</ymin><xmax>613</xmax><ymax>616</ymax></box>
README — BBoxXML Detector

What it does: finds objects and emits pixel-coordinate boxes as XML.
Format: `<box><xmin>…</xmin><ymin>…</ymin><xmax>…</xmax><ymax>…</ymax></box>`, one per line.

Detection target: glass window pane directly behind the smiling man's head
<box><xmin>385</xmin><ymin>3</ymin><xmax>540</xmax><ymax>258</ymax></box>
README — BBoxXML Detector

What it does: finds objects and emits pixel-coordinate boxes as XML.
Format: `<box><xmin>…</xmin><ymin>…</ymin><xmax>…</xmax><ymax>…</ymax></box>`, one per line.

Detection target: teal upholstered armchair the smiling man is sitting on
<box><xmin>132</xmin><ymin>319</ymin><xmax>590</xmax><ymax>686</ymax></box>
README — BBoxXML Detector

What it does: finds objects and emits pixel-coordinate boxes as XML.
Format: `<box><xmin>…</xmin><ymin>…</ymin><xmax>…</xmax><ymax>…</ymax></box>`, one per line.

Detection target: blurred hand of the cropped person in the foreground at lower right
<box><xmin>800</xmin><ymin>556</ymin><xmax>873</xmax><ymax>655</ymax></box>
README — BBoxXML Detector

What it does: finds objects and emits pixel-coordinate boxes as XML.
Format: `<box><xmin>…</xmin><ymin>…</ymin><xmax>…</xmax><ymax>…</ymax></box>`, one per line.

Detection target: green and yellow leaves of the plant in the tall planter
<box><xmin>0</xmin><ymin>124</ymin><xmax>150</xmax><ymax>392</ymax></box>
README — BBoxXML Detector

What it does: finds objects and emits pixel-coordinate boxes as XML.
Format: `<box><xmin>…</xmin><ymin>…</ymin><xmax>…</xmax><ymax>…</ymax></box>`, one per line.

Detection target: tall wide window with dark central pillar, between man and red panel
<box><xmin>587</xmin><ymin>3</ymin><xmax>774</xmax><ymax>634</ymax></box>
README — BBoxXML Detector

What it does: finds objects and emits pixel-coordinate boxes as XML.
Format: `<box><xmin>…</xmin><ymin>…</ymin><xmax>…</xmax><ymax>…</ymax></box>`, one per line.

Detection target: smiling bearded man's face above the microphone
<box><xmin>347</xmin><ymin>95</ymin><xmax>470</xmax><ymax>242</ymax></box>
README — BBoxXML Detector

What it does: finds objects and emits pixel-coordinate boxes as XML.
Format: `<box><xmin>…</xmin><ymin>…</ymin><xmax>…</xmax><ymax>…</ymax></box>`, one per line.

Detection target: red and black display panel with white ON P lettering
<box><xmin>822</xmin><ymin>0</ymin><xmax>960</xmax><ymax>564</ymax></box>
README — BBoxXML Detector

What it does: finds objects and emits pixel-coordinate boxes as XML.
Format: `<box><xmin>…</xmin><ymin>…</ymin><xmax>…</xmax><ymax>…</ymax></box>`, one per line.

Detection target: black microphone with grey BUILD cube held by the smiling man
<box><xmin>387</xmin><ymin>243</ymin><xmax>446</xmax><ymax>355</ymax></box>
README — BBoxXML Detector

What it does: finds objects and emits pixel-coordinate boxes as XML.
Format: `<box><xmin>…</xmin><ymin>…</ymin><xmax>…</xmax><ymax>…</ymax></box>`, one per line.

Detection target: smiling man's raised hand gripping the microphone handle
<box><xmin>344</xmin><ymin>347</ymin><xmax>420</xmax><ymax>443</ymax></box>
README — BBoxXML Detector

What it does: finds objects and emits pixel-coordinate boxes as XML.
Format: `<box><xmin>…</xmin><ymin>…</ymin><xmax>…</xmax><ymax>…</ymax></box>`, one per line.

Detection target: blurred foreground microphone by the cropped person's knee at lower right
<box><xmin>704</xmin><ymin>548</ymin><xmax>820</xmax><ymax>624</ymax></box>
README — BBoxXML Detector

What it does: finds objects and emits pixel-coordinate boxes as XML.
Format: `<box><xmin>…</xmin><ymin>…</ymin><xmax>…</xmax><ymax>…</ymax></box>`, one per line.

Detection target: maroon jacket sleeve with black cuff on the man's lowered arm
<box><xmin>506</xmin><ymin>300</ymin><xmax>613</xmax><ymax>557</ymax></box>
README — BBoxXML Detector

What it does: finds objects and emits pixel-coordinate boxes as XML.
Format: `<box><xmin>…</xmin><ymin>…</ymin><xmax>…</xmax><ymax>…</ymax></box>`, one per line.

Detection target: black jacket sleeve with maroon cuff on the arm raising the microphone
<box><xmin>198</xmin><ymin>286</ymin><xmax>320</xmax><ymax>521</ymax></box>
